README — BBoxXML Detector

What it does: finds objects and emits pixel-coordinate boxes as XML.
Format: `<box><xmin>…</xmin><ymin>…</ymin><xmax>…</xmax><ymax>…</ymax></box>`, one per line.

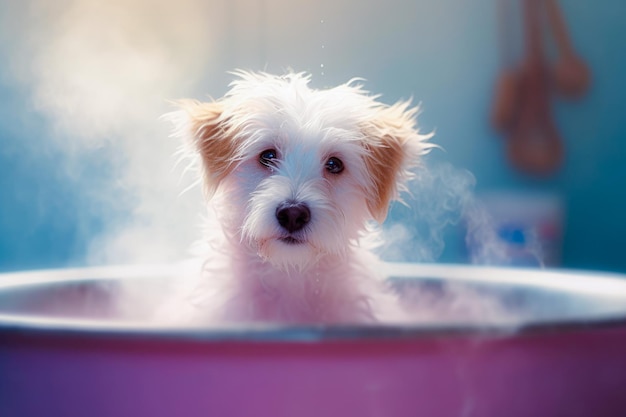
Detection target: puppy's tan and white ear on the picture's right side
<box><xmin>363</xmin><ymin>102</ymin><xmax>433</xmax><ymax>223</ymax></box>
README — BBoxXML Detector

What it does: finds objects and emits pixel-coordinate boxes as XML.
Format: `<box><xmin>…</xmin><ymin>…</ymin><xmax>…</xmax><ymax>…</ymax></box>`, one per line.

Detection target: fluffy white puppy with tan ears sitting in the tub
<box><xmin>163</xmin><ymin>71</ymin><xmax>432</xmax><ymax>324</ymax></box>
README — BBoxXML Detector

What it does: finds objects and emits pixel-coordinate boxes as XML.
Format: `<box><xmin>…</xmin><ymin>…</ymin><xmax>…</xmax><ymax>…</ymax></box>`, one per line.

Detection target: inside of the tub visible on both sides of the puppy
<box><xmin>0</xmin><ymin>264</ymin><xmax>626</xmax><ymax>331</ymax></box>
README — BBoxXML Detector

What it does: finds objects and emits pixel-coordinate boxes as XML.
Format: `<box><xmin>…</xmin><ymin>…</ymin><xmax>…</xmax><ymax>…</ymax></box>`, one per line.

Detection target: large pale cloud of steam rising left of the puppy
<box><xmin>0</xmin><ymin>0</ymin><xmax>221</xmax><ymax>263</ymax></box>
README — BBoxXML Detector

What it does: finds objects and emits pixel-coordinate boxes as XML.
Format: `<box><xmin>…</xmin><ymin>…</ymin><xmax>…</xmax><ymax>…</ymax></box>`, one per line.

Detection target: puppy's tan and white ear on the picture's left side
<box><xmin>168</xmin><ymin>100</ymin><xmax>237</xmax><ymax>195</ymax></box>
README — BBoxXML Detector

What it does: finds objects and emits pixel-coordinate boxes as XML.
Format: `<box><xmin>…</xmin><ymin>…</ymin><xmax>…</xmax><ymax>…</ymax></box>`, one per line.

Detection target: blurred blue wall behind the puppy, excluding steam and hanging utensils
<box><xmin>0</xmin><ymin>0</ymin><xmax>626</xmax><ymax>271</ymax></box>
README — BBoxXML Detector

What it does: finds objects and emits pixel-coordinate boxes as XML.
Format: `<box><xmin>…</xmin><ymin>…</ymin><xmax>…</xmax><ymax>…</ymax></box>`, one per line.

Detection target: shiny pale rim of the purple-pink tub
<box><xmin>0</xmin><ymin>263</ymin><xmax>626</xmax><ymax>343</ymax></box>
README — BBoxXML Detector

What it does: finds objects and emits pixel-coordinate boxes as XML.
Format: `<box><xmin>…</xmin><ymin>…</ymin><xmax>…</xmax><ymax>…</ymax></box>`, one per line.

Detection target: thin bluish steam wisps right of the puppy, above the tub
<box><xmin>382</xmin><ymin>162</ymin><xmax>508</xmax><ymax>265</ymax></box>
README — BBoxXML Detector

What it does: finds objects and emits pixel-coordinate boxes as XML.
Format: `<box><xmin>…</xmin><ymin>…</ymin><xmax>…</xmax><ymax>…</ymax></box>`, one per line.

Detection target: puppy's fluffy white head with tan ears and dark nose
<box><xmin>171</xmin><ymin>72</ymin><xmax>431</xmax><ymax>268</ymax></box>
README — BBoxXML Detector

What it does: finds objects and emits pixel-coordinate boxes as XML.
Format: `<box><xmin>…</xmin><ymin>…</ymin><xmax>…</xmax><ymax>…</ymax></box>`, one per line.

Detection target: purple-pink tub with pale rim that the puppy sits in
<box><xmin>0</xmin><ymin>264</ymin><xmax>626</xmax><ymax>417</ymax></box>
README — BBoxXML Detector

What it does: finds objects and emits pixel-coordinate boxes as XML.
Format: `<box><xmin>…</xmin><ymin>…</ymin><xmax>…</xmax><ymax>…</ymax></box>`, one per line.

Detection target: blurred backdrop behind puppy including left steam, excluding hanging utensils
<box><xmin>0</xmin><ymin>0</ymin><xmax>626</xmax><ymax>272</ymax></box>
